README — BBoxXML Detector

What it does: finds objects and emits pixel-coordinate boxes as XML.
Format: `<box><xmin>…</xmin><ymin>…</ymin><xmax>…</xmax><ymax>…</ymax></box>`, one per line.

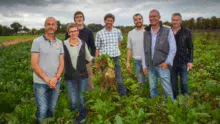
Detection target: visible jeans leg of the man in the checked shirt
<box><xmin>112</xmin><ymin>57</ymin><xmax>126</xmax><ymax>95</ymax></box>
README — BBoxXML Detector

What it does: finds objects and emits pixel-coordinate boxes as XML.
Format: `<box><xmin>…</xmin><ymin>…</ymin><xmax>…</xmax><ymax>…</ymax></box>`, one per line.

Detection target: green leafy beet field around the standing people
<box><xmin>0</xmin><ymin>32</ymin><xmax>220</xmax><ymax>124</ymax></box>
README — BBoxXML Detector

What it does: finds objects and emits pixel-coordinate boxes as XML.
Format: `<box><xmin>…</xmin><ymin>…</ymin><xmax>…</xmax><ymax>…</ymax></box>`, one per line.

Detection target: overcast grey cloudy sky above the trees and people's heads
<box><xmin>0</xmin><ymin>0</ymin><xmax>220</xmax><ymax>29</ymax></box>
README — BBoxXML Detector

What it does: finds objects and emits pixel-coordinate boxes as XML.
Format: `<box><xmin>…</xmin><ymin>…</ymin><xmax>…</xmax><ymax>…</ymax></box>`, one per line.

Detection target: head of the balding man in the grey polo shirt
<box><xmin>44</xmin><ymin>18</ymin><xmax>57</xmax><ymax>34</ymax></box>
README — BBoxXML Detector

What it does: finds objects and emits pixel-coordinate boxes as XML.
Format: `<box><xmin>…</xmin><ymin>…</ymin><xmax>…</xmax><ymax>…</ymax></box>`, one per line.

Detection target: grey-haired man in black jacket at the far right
<box><xmin>171</xmin><ymin>13</ymin><xmax>193</xmax><ymax>99</ymax></box>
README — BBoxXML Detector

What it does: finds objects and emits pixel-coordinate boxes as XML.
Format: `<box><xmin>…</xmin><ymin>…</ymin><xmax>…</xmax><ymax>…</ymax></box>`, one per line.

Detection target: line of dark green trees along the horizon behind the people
<box><xmin>0</xmin><ymin>16</ymin><xmax>220</xmax><ymax>36</ymax></box>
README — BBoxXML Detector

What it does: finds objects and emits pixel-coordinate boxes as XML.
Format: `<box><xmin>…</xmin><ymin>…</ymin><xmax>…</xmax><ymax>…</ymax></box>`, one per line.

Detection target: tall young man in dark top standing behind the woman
<box><xmin>65</xmin><ymin>11</ymin><xmax>96</xmax><ymax>91</ymax></box>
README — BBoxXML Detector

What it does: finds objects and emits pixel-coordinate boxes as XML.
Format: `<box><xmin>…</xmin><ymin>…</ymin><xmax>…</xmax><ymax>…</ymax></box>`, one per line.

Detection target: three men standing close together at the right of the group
<box><xmin>126</xmin><ymin>10</ymin><xmax>193</xmax><ymax>100</ymax></box>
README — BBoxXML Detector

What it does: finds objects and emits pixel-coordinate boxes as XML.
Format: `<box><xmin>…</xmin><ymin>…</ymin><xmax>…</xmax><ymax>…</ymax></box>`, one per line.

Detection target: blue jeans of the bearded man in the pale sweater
<box><xmin>134</xmin><ymin>60</ymin><xmax>146</xmax><ymax>84</ymax></box>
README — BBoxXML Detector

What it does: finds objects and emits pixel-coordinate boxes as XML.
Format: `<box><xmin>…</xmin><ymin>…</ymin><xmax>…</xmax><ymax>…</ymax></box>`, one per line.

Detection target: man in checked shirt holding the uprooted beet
<box><xmin>95</xmin><ymin>13</ymin><xmax>126</xmax><ymax>95</ymax></box>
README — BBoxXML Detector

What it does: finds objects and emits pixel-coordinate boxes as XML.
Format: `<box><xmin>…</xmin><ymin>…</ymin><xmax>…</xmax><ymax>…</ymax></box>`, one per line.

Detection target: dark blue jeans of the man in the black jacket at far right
<box><xmin>171</xmin><ymin>64</ymin><xmax>188</xmax><ymax>99</ymax></box>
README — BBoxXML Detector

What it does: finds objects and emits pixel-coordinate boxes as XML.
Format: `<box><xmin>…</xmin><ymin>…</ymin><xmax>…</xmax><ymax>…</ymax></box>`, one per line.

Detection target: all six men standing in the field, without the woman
<box><xmin>31</xmin><ymin>10</ymin><xmax>193</xmax><ymax>121</ymax></box>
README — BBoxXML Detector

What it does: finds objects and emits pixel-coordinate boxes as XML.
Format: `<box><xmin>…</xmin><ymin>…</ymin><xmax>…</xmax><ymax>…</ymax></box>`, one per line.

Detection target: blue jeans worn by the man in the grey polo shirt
<box><xmin>34</xmin><ymin>82</ymin><xmax>60</xmax><ymax>122</ymax></box>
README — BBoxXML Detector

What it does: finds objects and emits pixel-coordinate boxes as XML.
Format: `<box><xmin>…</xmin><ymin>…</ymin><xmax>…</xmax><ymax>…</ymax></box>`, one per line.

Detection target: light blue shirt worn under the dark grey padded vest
<box><xmin>142</xmin><ymin>27</ymin><xmax>176</xmax><ymax>68</ymax></box>
